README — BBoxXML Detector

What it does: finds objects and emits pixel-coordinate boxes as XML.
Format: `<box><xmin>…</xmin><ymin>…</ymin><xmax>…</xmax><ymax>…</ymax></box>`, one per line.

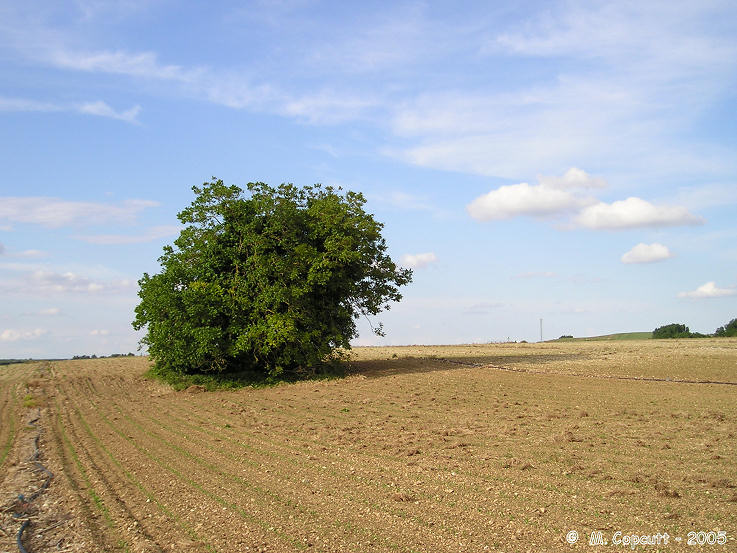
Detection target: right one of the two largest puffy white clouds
<box><xmin>574</xmin><ymin>197</ymin><xmax>704</xmax><ymax>230</ymax></box>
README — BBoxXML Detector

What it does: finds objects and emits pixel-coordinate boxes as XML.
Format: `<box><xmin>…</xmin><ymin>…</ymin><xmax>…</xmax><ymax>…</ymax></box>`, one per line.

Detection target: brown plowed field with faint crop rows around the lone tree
<box><xmin>0</xmin><ymin>339</ymin><xmax>737</xmax><ymax>553</ymax></box>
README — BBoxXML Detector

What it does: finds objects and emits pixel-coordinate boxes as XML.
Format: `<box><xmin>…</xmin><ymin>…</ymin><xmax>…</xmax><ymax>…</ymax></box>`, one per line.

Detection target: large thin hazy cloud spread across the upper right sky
<box><xmin>388</xmin><ymin>1</ymin><xmax>737</xmax><ymax>178</ymax></box>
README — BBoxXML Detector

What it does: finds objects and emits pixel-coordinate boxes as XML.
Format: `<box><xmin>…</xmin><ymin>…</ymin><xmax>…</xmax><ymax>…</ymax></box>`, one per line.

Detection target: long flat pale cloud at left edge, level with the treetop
<box><xmin>0</xmin><ymin>196</ymin><xmax>159</xmax><ymax>228</ymax></box>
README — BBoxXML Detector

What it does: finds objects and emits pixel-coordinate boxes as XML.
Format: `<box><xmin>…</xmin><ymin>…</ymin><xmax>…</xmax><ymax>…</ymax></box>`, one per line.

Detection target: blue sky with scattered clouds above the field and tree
<box><xmin>0</xmin><ymin>0</ymin><xmax>737</xmax><ymax>358</ymax></box>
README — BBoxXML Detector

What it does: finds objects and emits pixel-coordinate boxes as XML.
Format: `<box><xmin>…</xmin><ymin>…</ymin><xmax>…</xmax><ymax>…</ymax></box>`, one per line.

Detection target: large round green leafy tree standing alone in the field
<box><xmin>133</xmin><ymin>178</ymin><xmax>412</xmax><ymax>378</ymax></box>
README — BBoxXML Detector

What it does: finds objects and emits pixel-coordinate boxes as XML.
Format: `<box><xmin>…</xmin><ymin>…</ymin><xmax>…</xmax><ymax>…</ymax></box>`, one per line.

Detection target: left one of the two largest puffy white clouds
<box><xmin>466</xmin><ymin>178</ymin><xmax>592</xmax><ymax>221</ymax></box>
